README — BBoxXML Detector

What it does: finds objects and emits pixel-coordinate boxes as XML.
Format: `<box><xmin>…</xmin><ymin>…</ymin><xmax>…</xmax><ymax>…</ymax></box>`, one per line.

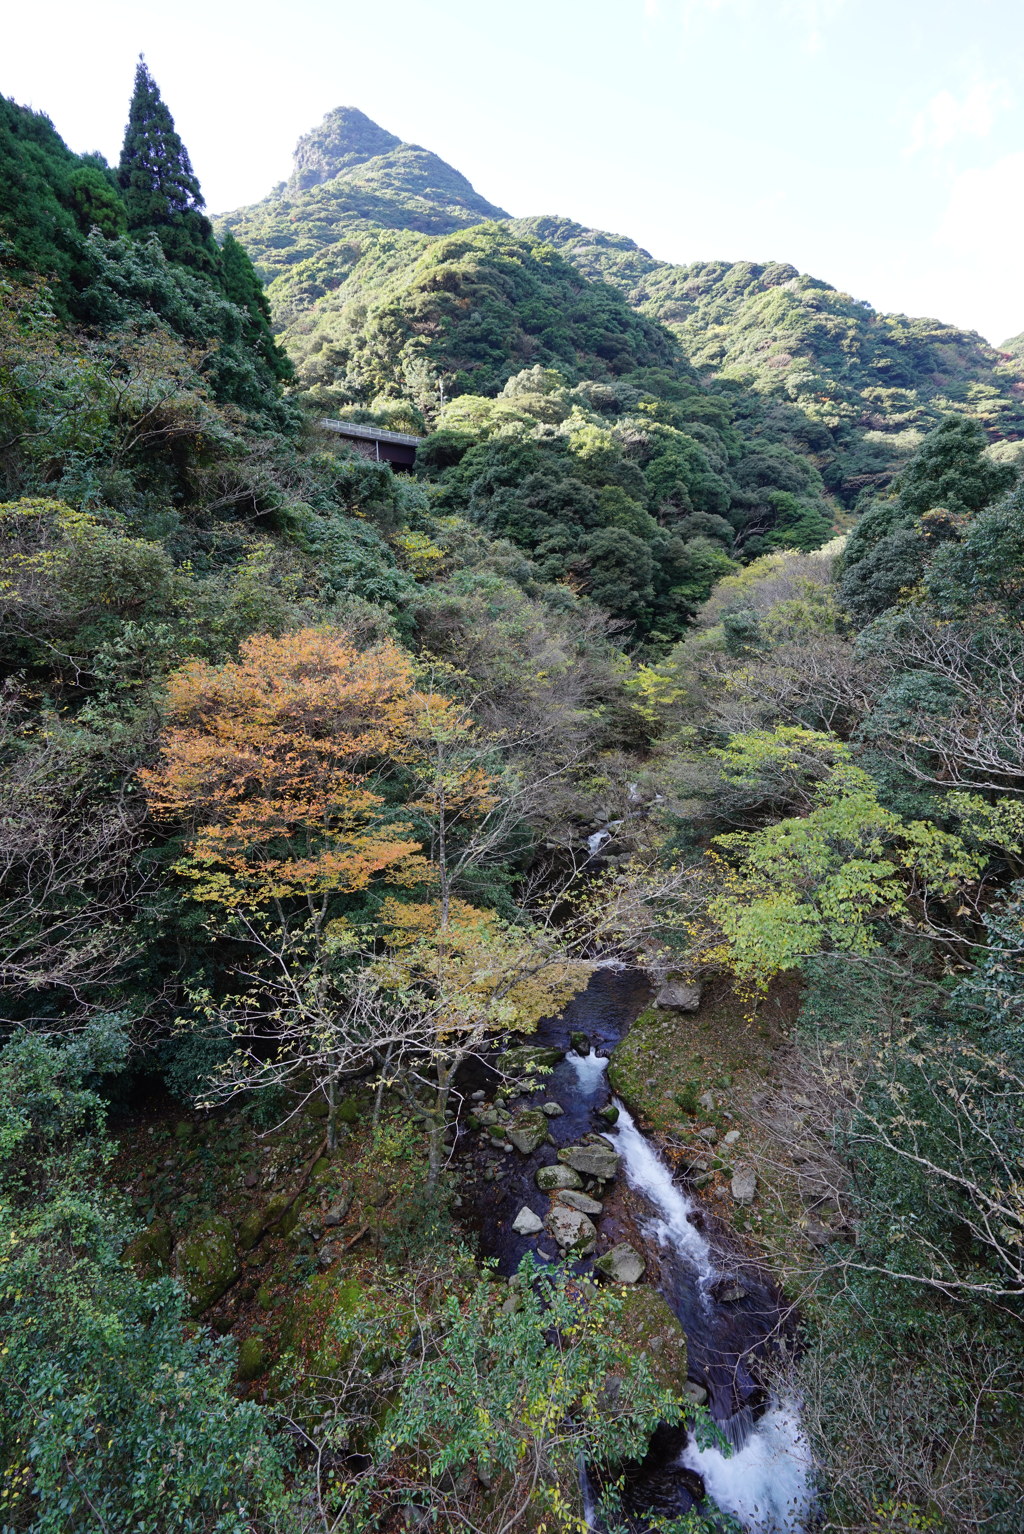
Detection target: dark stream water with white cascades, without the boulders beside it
<box><xmin>457</xmin><ymin>969</ymin><xmax>812</xmax><ymax>1534</ymax></box>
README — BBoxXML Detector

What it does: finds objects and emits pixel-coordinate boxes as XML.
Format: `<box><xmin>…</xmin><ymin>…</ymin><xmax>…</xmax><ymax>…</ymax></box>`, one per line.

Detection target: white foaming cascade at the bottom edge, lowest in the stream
<box><xmin>679</xmin><ymin>1401</ymin><xmax>814</xmax><ymax>1534</ymax></box>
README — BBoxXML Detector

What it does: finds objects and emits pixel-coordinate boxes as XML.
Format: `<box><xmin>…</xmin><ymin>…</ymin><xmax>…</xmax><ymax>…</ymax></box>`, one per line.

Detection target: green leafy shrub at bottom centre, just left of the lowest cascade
<box><xmin>294</xmin><ymin>1256</ymin><xmax>711</xmax><ymax>1534</ymax></box>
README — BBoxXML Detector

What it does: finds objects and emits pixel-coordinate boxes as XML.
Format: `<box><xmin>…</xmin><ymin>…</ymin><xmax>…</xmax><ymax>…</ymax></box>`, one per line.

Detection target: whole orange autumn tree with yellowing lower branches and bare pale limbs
<box><xmin>143</xmin><ymin>629</ymin><xmax>587</xmax><ymax>1159</ymax></box>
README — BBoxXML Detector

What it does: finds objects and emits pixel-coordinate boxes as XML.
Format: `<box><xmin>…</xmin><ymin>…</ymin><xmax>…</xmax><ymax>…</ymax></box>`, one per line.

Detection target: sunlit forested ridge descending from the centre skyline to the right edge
<box><xmin>512</xmin><ymin>218</ymin><xmax>1024</xmax><ymax>503</ymax></box>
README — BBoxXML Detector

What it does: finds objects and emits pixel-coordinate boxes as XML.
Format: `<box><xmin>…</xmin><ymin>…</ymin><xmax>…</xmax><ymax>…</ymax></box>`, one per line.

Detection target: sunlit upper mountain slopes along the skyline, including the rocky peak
<box><xmin>218</xmin><ymin>107</ymin><xmax>1024</xmax><ymax>508</ymax></box>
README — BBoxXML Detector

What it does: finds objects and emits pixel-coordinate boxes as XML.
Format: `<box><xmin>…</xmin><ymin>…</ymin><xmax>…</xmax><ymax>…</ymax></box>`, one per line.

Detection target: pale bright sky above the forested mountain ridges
<box><xmin>8</xmin><ymin>0</ymin><xmax>1024</xmax><ymax>344</ymax></box>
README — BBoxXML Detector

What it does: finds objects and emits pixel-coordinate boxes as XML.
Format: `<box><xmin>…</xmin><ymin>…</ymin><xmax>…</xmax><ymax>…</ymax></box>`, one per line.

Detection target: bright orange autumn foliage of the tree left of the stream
<box><xmin>141</xmin><ymin>629</ymin><xmax>452</xmax><ymax>911</ymax></box>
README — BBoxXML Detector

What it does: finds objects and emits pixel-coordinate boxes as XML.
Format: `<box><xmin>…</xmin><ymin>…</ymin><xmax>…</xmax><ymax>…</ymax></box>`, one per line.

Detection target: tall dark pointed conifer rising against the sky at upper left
<box><xmin>118</xmin><ymin>57</ymin><xmax>219</xmax><ymax>276</ymax></box>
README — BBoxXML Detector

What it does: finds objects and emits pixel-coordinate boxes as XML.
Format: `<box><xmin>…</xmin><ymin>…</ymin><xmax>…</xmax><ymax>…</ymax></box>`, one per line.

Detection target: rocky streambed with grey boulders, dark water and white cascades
<box><xmin>455</xmin><ymin>969</ymin><xmax>811</xmax><ymax>1534</ymax></box>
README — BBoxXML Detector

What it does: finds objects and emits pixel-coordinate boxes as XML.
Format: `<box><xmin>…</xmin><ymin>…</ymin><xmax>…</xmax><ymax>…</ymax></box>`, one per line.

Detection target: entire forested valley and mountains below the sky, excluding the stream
<box><xmin>0</xmin><ymin>61</ymin><xmax>1024</xmax><ymax>1534</ymax></box>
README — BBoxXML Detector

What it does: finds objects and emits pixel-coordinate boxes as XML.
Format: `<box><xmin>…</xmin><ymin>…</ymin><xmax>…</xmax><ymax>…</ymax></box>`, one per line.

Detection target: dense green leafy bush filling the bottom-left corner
<box><xmin>0</xmin><ymin>1017</ymin><xmax>282</xmax><ymax>1534</ymax></box>
